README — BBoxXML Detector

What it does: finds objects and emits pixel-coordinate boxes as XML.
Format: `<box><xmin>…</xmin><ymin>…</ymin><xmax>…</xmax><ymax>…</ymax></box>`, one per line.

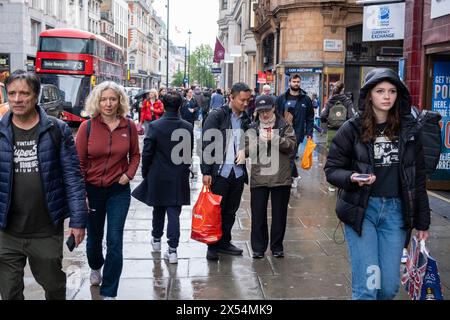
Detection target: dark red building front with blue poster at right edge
<box><xmin>403</xmin><ymin>0</ymin><xmax>450</xmax><ymax>189</ymax></box>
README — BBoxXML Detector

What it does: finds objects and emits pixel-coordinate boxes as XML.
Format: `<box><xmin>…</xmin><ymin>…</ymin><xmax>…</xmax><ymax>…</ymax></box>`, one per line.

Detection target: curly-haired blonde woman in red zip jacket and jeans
<box><xmin>76</xmin><ymin>81</ymin><xmax>140</xmax><ymax>299</ymax></box>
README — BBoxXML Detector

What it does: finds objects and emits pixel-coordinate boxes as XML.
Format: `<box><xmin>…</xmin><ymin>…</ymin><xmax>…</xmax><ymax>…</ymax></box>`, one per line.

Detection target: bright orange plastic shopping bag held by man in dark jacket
<box><xmin>191</xmin><ymin>186</ymin><xmax>222</xmax><ymax>244</ymax></box>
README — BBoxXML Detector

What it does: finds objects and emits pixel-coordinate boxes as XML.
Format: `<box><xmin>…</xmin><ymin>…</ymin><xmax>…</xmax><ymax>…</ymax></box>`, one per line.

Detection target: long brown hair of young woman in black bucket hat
<box><xmin>361</xmin><ymin>88</ymin><xmax>401</xmax><ymax>143</ymax></box>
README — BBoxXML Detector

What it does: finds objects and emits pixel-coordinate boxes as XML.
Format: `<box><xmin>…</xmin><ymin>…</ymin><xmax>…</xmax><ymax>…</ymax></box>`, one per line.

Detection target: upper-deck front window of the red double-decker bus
<box><xmin>39</xmin><ymin>37</ymin><xmax>93</xmax><ymax>54</ymax></box>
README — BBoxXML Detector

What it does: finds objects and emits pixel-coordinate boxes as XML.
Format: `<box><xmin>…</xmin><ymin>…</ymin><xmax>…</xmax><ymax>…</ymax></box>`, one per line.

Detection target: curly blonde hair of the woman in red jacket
<box><xmin>86</xmin><ymin>81</ymin><xmax>130</xmax><ymax>117</ymax></box>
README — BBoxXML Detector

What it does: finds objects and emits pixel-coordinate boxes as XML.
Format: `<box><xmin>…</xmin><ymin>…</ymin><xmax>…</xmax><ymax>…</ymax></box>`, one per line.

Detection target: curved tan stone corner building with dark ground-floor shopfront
<box><xmin>253</xmin><ymin>0</ymin><xmax>362</xmax><ymax>102</ymax></box>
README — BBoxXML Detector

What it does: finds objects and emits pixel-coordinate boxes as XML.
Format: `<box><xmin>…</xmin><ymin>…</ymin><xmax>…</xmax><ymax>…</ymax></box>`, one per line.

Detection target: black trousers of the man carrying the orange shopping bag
<box><xmin>208</xmin><ymin>170</ymin><xmax>244</xmax><ymax>249</ymax></box>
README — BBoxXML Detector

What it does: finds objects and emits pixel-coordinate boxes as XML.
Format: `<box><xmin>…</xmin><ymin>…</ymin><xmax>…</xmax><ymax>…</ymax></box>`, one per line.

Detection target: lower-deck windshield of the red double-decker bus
<box><xmin>39</xmin><ymin>74</ymin><xmax>90</xmax><ymax>115</ymax></box>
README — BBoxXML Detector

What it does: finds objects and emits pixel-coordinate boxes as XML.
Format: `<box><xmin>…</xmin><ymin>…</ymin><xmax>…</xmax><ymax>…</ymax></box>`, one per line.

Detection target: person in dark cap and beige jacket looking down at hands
<box><xmin>246</xmin><ymin>95</ymin><xmax>297</xmax><ymax>259</ymax></box>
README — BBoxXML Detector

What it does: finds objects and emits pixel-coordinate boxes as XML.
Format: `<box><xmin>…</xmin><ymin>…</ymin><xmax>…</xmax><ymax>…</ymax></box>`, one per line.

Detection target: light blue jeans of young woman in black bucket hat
<box><xmin>345</xmin><ymin>197</ymin><xmax>406</xmax><ymax>300</ymax></box>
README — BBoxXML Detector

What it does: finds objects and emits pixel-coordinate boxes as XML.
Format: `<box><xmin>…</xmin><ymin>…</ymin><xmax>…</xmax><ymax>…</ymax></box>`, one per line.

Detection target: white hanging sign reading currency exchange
<box><xmin>363</xmin><ymin>0</ymin><xmax>406</xmax><ymax>41</ymax></box>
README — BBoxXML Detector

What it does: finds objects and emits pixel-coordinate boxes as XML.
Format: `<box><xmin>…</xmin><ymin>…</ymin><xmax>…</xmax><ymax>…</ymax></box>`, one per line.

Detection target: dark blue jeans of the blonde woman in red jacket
<box><xmin>86</xmin><ymin>183</ymin><xmax>131</xmax><ymax>297</ymax></box>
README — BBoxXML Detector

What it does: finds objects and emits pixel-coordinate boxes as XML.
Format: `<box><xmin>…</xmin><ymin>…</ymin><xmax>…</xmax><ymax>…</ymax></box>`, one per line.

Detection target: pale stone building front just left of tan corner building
<box><xmin>218</xmin><ymin>0</ymin><xmax>257</xmax><ymax>89</ymax></box>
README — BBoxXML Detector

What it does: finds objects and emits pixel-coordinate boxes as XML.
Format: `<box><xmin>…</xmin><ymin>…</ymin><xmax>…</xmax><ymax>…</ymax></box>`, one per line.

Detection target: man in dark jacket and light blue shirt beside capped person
<box><xmin>201</xmin><ymin>83</ymin><xmax>251</xmax><ymax>260</ymax></box>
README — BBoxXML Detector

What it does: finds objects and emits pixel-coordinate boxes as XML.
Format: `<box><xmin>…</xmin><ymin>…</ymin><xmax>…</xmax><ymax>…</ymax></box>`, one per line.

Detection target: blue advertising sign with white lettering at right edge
<box><xmin>430</xmin><ymin>61</ymin><xmax>450</xmax><ymax>181</ymax></box>
